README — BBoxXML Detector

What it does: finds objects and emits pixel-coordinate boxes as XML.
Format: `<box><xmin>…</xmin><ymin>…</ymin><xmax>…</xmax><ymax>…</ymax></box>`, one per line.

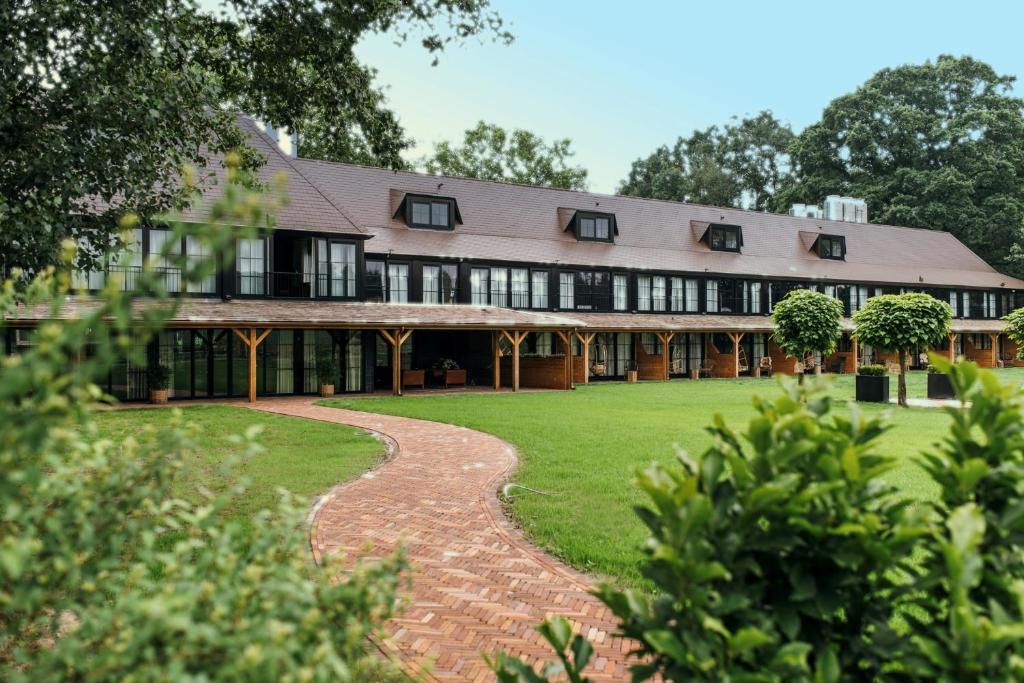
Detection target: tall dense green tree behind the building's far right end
<box><xmin>774</xmin><ymin>55</ymin><xmax>1024</xmax><ymax>274</ymax></box>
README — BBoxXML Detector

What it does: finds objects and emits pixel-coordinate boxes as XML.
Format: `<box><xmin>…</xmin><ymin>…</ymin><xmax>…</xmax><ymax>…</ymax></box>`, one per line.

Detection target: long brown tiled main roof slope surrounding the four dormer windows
<box><xmin>276</xmin><ymin>154</ymin><xmax>1024</xmax><ymax>289</ymax></box>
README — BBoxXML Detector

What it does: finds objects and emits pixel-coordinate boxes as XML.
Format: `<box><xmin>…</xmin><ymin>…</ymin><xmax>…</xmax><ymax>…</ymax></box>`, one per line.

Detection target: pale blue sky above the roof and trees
<box><xmin>357</xmin><ymin>0</ymin><xmax>1024</xmax><ymax>193</ymax></box>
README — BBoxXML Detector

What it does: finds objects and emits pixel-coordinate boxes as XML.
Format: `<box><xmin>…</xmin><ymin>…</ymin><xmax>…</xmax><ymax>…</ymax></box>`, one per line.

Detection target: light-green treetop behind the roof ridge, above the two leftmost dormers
<box><xmin>426</xmin><ymin>121</ymin><xmax>587</xmax><ymax>189</ymax></box>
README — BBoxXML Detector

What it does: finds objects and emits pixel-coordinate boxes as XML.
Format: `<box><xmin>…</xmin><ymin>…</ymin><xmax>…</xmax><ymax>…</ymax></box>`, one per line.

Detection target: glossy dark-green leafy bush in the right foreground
<box><xmin>493</xmin><ymin>357</ymin><xmax>1024</xmax><ymax>683</ymax></box>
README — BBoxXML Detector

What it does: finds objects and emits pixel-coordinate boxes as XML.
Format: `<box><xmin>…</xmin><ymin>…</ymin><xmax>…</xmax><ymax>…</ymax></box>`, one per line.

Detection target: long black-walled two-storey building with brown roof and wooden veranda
<box><xmin>7</xmin><ymin>120</ymin><xmax>1024</xmax><ymax>399</ymax></box>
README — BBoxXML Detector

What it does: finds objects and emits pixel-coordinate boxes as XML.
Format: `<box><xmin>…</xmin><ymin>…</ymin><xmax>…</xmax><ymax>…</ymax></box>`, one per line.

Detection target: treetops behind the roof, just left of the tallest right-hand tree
<box><xmin>618</xmin><ymin>112</ymin><xmax>794</xmax><ymax>211</ymax></box>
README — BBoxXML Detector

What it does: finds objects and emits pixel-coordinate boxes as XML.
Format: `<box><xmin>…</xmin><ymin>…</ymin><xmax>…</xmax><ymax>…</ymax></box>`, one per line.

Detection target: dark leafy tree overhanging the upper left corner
<box><xmin>0</xmin><ymin>0</ymin><xmax>509</xmax><ymax>272</ymax></box>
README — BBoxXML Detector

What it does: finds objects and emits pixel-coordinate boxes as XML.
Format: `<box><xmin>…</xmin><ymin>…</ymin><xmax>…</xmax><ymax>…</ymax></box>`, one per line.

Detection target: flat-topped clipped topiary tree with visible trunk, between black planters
<box><xmin>853</xmin><ymin>293</ymin><xmax>952</xmax><ymax>405</ymax></box>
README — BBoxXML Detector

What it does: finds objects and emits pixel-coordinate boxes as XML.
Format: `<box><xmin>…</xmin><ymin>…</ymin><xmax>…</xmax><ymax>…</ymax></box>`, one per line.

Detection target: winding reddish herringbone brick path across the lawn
<box><xmin>249</xmin><ymin>398</ymin><xmax>629</xmax><ymax>681</ymax></box>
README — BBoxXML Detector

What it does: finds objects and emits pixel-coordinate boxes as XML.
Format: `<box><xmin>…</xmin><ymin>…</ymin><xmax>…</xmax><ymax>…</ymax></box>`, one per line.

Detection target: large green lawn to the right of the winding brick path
<box><xmin>324</xmin><ymin>369</ymin><xmax>1024</xmax><ymax>586</ymax></box>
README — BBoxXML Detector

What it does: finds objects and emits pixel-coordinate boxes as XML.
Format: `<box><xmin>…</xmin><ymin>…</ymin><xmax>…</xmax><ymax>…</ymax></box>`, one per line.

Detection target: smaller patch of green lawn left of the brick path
<box><xmin>96</xmin><ymin>405</ymin><xmax>384</xmax><ymax>522</ymax></box>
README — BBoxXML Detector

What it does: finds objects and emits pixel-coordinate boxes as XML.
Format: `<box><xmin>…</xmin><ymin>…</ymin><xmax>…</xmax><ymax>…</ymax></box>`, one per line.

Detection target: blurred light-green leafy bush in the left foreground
<box><xmin>0</xmin><ymin>163</ymin><xmax>404</xmax><ymax>682</ymax></box>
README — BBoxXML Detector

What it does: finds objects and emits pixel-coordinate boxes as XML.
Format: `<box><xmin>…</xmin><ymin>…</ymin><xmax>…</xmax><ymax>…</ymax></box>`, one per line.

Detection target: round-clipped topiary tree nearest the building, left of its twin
<box><xmin>771</xmin><ymin>290</ymin><xmax>843</xmax><ymax>381</ymax></box>
